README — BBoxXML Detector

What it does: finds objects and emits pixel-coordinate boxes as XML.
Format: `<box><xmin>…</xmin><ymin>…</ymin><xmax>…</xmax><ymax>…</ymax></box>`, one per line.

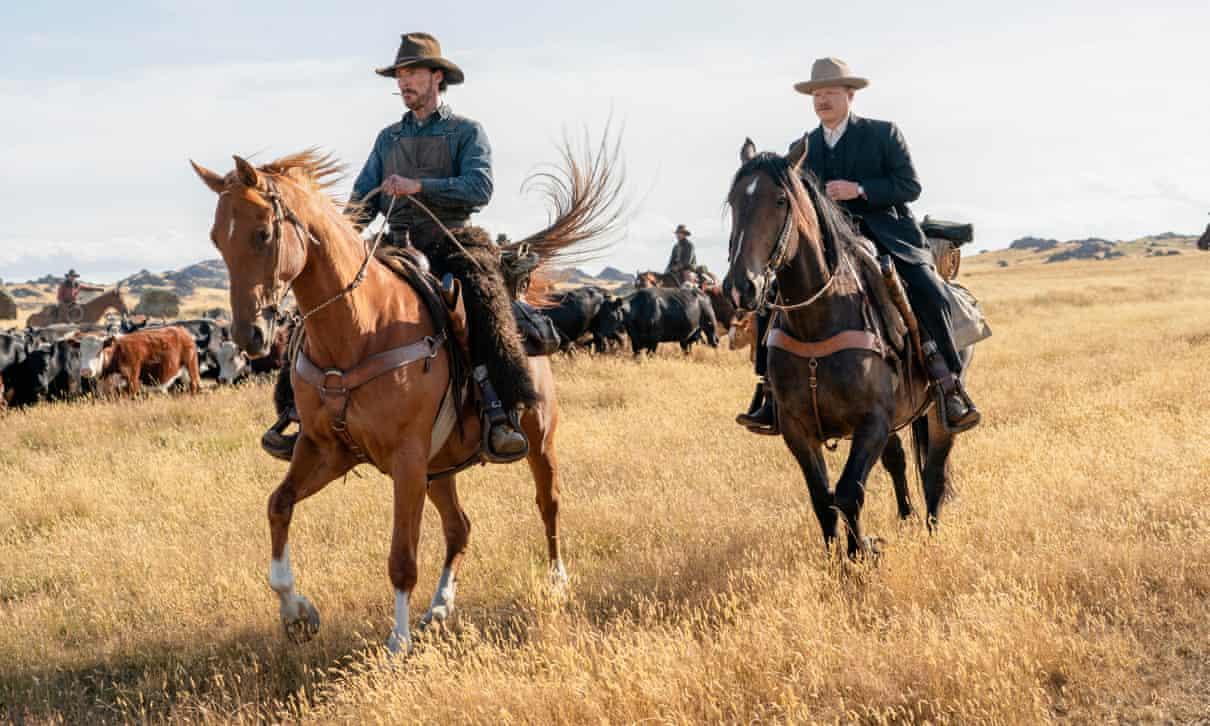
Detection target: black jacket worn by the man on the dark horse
<box><xmin>803</xmin><ymin>116</ymin><xmax>933</xmax><ymax>265</ymax></box>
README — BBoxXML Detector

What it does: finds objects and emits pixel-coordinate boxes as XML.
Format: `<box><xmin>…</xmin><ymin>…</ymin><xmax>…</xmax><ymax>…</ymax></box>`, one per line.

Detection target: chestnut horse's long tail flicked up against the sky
<box><xmin>505</xmin><ymin>126</ymin><xmax>626</xmax><ymax>306</ymax></box>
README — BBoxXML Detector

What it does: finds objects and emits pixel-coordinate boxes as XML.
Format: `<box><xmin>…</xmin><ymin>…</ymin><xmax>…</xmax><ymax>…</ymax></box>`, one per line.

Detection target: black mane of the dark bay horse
<box><xmin>731</xmin><ymin>151</ymin><xmax>860</xmax><ymax>270</ymax></box>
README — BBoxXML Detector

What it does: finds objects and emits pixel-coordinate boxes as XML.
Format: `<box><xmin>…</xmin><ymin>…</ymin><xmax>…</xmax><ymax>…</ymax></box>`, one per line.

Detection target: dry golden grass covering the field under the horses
<box><xmin>0</xmin><ymin>257</ymin><xmax>1210</xmax><ymax>724</ymax></box>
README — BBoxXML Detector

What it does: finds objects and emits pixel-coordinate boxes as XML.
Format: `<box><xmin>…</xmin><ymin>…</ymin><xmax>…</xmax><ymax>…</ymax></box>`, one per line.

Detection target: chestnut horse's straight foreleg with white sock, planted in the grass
<box><xmin>386</xmin><ymin>445</ymin><xmax>428</xmax><ymax>653</ymax></box>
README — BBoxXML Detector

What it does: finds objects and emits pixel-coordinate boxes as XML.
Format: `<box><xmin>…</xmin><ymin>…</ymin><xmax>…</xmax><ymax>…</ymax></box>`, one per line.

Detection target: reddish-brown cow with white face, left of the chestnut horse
<box><xmin>80</xmin><ymin>325</ymin><xmax>201</xmax><ymax>394</ymax></box>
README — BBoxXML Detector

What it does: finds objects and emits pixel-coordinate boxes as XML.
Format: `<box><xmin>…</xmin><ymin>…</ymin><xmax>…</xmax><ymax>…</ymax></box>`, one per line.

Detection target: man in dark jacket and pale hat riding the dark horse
<box><xmin>736</xmin><ymin>58</ymin><xmax>979</xmax><ymax>434</ymax></box>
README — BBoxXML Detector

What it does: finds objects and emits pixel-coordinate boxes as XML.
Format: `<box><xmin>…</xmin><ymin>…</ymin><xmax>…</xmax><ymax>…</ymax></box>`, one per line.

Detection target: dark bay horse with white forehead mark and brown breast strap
<box><xmin>726</xmin><ymin>140</ymin><xmax>969</xmax><ymax>557</ymax></box>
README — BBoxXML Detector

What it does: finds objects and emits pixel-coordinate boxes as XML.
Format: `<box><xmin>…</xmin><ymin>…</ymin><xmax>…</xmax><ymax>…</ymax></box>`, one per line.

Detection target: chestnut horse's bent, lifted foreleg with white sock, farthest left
<box><xmin>269</xmin><ymin>436</ymin><xmax>351</xmax><ymax>643</ymax></box>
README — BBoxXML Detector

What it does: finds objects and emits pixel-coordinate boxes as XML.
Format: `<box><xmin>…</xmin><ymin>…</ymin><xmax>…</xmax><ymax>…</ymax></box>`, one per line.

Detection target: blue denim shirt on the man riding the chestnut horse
<box><xmin>350</xmin><ymin>103</ymin><xmax>492</xmax><ymax>226</ymax></box>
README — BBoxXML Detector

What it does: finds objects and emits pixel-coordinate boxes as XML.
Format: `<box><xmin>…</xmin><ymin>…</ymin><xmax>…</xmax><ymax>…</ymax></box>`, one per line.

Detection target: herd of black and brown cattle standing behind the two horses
<box><xmin>0</xmin><ymin>274</ymin><xmax>750</xmax><ymax>408</ymax></box>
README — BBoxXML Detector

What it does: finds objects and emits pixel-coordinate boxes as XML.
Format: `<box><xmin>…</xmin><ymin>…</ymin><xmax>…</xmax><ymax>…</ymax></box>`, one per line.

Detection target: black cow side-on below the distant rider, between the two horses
<box><xmin>614</xmin><ymin>287</ymin><xmax>719</xmax><ymax>356</ymax></box>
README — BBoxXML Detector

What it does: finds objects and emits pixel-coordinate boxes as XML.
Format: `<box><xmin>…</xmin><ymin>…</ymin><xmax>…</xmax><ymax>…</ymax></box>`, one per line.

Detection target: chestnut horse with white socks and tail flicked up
<box><xmin>194</xmin><ymin>141</ymin><xmax>618</xmax><ymax>652</ymax></box>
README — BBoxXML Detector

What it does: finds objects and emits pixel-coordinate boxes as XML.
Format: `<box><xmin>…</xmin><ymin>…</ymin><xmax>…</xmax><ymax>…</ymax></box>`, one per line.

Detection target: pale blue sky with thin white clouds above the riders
<box><xmin>0</xmin><ymin>0</ymin><xmax>1210</xmax><ymax>280</ymax></box>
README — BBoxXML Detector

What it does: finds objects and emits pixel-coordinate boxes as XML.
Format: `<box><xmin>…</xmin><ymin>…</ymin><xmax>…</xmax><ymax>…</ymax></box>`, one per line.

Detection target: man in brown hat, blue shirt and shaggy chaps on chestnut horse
<box><xmin>266</xmin><ymin>33</ymin><xmax>527</xmax><ymax>462</ymax></box>
